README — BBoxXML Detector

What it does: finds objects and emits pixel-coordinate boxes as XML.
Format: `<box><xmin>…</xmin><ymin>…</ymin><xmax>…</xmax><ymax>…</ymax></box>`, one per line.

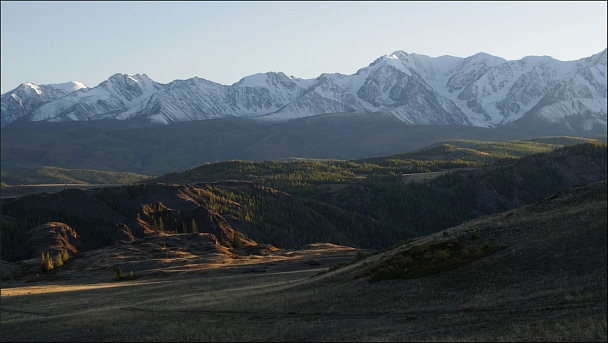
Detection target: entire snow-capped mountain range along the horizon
<box><xmin>1</xmin><ymin>50</ymin><xmax>607</xmax><ymax>131</ymax></box>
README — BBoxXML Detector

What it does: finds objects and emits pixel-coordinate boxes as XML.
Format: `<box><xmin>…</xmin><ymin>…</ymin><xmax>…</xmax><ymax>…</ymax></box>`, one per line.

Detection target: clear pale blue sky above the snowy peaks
<box><xmin>0</xmin><ymin>1</ymin><xmax>608</xmax><ymax>94</ymax></box>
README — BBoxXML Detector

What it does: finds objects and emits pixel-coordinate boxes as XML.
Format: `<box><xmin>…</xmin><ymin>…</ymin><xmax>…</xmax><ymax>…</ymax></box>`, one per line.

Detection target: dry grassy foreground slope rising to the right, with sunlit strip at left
<box><xmin>0</xmin><ymin>180</ymin><xmax>608</xmax><ymax>342</ymax></box>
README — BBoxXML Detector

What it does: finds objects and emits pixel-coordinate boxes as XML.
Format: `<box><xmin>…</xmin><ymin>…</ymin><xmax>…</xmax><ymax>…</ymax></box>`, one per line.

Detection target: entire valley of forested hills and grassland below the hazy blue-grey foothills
<box><xmin>0</xmin><ymin>136</ymin><xmax>608</xmax><ymax>341</ymax></box>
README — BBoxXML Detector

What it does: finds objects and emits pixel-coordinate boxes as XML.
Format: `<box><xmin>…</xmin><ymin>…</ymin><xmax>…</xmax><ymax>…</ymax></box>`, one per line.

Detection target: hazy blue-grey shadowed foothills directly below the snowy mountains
<box><xmin>1</xmin><ymin>113</ymin><xmax>600</xmax><ymax>175</ymax></box>
